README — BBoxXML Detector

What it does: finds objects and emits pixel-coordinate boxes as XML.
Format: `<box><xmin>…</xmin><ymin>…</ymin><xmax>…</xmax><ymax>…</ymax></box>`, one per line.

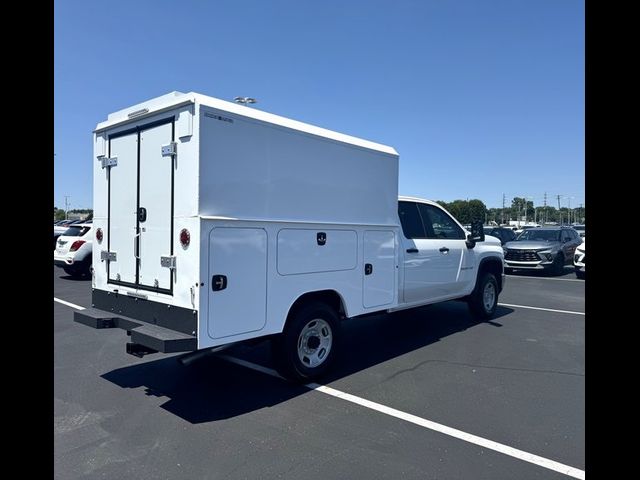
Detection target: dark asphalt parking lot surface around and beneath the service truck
<box><xmin>54</xmin><ymin>267</ymin><xmax>585</xmax><ymax>480</ymax></box>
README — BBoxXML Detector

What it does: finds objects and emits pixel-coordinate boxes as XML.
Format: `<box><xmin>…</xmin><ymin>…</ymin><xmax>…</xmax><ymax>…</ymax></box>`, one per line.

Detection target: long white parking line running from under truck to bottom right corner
<box><xmin>218</xmin><ymin>355</ymin><xmax>585</xmax><ymax>480</ymax></box>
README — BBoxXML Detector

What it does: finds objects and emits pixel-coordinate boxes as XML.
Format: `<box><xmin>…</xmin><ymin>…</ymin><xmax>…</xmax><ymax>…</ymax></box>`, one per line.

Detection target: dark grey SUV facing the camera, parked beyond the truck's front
<box><xmin>503</xmin><ymin>227</ymin><xmax>582</xmax><ymax>275</ymax></box>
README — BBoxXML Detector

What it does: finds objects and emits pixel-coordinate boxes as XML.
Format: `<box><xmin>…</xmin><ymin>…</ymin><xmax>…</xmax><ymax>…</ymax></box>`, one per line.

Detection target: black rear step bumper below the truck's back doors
<box><xmin>73</xmin><ymin>308</ymin><xmax>198</xmax><ymax>357</ymax></box>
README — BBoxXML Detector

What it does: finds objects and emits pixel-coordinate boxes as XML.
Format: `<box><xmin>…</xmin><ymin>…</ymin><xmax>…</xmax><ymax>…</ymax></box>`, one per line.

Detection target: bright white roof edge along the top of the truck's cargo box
<box><xmin>94</xmin><ymin>91</ymin><xmax>398</xmax><ymax>156</ymax></box>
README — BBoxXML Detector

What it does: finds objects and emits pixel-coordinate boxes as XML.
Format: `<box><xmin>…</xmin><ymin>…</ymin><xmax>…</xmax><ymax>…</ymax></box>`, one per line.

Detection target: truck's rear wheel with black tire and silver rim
<box><xmin>271</xmin><ymin>302</ymin><xmax>340</xmax><ymax>382</ymax></box>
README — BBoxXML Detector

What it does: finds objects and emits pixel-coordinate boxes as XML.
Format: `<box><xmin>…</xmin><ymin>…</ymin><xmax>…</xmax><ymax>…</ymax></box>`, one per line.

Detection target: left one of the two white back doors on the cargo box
<box><xmin>107</xmin><ymin>131</ymin><xmax>138</xmax><ymax>284</ymax></box>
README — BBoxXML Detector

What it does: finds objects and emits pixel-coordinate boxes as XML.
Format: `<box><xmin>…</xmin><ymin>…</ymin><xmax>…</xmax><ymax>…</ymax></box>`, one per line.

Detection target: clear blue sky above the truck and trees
<box><xmin>52</xmin><ymin>0</ymin><xmax>585</xmax><ymax>208</ymax></box>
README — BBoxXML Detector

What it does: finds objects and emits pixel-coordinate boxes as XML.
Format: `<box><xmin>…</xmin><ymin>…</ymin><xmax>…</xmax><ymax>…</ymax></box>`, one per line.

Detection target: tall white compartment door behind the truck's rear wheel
<box><xmin>208</xmin><ymin>227</ymin><xmax>267</xmax><ymax>338</ymax></box>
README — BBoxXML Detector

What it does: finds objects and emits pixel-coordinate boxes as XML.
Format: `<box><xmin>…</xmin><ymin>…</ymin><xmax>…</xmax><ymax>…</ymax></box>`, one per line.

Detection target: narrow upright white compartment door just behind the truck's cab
<box><xmin>362</xmin><ymin>230</ymin><xmax>397</xmax><ymax>308</ymax></box>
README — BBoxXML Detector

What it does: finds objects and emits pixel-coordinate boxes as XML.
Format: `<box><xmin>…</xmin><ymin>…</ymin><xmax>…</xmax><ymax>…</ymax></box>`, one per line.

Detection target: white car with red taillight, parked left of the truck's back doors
<box><xmin>53</xmin><ymin>223</ymin><xmax>93</xmax><ymax>277</ymax></box>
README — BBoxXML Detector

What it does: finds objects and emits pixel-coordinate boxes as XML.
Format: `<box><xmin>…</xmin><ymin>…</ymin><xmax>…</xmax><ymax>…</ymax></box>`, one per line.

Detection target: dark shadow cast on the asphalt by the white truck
<box><xmin>102</xmin><ymin>302</ymin><xmax>513</xmax><ymax>424</ymax></box>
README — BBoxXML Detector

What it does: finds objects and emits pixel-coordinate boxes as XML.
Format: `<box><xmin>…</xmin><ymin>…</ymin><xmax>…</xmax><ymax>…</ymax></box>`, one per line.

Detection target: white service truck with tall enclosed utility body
<box><xmin>74</xmin><ymin>92</ymin><xmax>504</xmax><ymax>381</ymax></box>
